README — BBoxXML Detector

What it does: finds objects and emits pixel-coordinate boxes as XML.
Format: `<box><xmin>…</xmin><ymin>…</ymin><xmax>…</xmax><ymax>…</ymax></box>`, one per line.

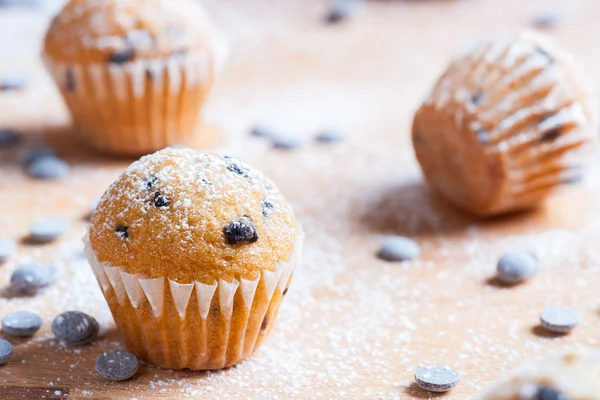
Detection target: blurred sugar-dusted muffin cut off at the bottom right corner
<box><xmin>480</xmin><ymin>349</ymin><xmax>600</xmax><ymax>400</ymax></box>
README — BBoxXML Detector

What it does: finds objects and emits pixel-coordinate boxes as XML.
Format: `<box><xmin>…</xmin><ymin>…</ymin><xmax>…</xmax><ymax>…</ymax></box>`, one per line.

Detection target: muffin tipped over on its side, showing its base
<box><xmin>412</xmin><ymin>34</ymin><xmax>596</xmax><ymax>216</ymax></box>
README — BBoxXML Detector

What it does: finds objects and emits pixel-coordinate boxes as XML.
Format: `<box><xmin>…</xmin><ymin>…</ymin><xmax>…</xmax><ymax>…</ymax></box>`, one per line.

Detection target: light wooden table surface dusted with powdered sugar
<box><xmin>0</xmin><ymin>0</ymin><xmax>600</xmax><ymax>400</ymax></box>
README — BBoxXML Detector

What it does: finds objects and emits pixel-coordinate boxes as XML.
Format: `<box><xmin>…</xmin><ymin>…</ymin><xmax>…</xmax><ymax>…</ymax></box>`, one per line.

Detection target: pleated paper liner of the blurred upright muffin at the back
<box><xmin>44</xmin><ymin>40</ymin><xmax>227</xmax><ymax>154</ymax></box>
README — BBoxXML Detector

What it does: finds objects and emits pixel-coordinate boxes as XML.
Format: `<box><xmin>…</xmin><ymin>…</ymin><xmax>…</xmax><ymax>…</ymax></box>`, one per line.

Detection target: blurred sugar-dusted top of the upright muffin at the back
<box><xmin>44</xmin><ymin>0</ymin><xmax>214</xmax><ymax>64</ymax></box>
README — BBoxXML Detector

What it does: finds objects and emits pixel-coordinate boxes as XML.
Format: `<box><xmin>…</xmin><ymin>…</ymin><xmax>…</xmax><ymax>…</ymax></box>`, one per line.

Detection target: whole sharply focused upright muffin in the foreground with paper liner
<box><xmin>86</xmin><ymin>149</ymin><xmax>302</xmax><ymax>369</ymax></box>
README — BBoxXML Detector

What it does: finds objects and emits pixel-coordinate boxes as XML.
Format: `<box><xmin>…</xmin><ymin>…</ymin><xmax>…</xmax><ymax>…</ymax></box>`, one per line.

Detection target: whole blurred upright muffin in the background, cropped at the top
<box><xmin>44</xmin><ymin>0</ymin><xmax>225</xmax><ymax>155</ymax></box>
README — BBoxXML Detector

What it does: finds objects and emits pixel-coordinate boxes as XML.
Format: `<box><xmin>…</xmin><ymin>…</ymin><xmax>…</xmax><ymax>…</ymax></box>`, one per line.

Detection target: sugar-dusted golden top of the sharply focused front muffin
<box><xmin>89</xmin><ymin>149</ymin><xmax>297</xmax><ymax>284</ymax></box>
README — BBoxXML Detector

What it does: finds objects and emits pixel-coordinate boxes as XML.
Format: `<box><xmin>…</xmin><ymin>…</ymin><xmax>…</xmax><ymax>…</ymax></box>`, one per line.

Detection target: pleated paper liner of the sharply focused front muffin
<box><xmin>83</xmin><ymin>231</ymin><xmax>304</xmax><ymax>370</ymax></box>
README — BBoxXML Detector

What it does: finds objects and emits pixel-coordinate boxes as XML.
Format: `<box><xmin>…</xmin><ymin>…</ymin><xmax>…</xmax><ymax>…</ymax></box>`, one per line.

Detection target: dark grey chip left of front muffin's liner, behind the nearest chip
<box><xmin>52</xmin><ymin>311</ymin><xmax>100</xmax><ymax>346</ymax></box>
